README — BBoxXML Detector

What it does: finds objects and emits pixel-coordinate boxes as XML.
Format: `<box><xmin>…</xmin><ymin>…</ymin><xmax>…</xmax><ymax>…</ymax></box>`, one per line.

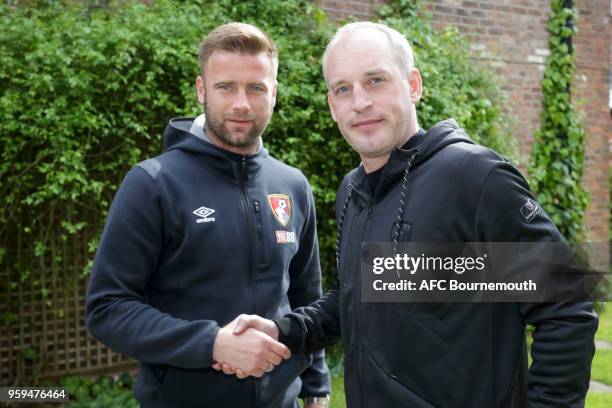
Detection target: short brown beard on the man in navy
<box><xmin>204</xmin><ymin>98</ymin><xmax>272</xmax><ymax>149</ymax></box>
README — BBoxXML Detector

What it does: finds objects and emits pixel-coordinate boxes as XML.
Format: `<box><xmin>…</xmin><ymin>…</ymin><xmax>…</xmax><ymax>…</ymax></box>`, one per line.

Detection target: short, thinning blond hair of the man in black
<box><xmin>323</xmin><ymin>21</ymin><xmax>414</xmax><ymax>87</ymax></box>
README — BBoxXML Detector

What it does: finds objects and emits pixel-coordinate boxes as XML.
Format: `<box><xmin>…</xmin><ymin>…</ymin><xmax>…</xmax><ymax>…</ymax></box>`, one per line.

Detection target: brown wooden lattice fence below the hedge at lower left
<box><xmin>0</xmin><ymin>215</ymin><xmax>135</xmax><ymax>386</ymax></box>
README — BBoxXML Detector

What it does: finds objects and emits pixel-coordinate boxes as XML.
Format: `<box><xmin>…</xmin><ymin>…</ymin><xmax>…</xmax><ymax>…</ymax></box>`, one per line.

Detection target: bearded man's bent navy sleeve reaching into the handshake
<box><xmin>86</xmin><ymin>167</ymin><xmax>219</xmax><ymax>368</ymax></box>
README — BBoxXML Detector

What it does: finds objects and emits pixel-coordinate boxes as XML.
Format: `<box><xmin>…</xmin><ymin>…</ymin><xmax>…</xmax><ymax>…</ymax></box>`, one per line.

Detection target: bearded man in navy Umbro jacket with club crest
<box><xmin>86</xmin><ymin>23</ymin><xmax>329</xmax><ymax>408</ymax></box>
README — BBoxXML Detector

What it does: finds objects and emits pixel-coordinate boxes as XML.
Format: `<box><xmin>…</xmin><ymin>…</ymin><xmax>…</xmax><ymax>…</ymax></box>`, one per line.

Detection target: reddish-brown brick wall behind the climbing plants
<box><xmin>318</xmin><ymin>0</ymin><xmax>612</xmax><ymax>242</ymax></box>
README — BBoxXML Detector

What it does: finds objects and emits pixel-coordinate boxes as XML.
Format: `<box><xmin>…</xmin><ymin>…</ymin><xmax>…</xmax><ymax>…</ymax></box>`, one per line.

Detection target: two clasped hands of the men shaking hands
<box><xmin>212</xmin><ymin>314</ymin><xmax>291</xmax><ymax>379</ymax></box>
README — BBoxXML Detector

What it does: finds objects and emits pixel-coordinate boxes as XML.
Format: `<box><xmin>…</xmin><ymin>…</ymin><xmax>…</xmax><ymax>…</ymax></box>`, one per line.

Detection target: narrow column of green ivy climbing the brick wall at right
<box><xmin>530</xmin><ymin>0</ymin><xmax>589</xmax><ymax>242</ymax></box>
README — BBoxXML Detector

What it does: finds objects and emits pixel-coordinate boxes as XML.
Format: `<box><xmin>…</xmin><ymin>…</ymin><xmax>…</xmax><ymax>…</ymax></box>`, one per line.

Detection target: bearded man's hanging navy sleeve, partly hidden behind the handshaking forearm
<box><xmin>288</xmin><ymin>181</ymin><xmax>331</xmax><ymax>397</ymax></box>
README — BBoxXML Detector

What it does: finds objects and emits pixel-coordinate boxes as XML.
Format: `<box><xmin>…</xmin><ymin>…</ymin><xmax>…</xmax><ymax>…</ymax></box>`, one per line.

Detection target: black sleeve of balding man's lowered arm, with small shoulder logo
<box><xmin>475</xmin><ymin>163</ymin><xmax>598</xmax><ymax>408</ymax></box>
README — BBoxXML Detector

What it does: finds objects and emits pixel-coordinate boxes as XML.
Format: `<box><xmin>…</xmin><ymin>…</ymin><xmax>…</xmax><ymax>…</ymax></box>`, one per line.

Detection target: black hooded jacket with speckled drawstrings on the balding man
<box><xmin>276</xmin><ymin>120</ymin><xmax>597</xmax><ymax>408</ymax></box>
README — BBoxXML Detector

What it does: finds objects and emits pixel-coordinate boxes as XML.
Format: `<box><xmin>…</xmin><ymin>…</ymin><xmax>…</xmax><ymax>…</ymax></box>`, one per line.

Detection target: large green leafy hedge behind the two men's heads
<box><xmin>0</xmin><ymin>0</ymin><xmax>513</xmax><ymax>294</ymax></box>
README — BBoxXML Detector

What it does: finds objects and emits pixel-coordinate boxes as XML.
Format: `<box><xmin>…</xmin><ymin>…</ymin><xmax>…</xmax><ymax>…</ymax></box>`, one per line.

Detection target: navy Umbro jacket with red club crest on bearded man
<box><xmin>86</xmin><ymin>119</ymin><xmax>330</xmax><ymax>408</ymax></box>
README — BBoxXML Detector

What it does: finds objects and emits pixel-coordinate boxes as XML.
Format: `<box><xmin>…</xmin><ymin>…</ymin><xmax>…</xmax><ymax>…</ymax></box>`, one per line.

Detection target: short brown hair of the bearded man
<box><xmin>200</xmin><ymin>23</ymin><xmax>278</xmax><ymax>75</ymax></box>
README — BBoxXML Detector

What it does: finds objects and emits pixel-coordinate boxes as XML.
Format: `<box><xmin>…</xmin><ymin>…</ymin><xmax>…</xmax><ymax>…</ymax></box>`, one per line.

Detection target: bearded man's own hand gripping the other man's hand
<box><xmin>213</xmin><ymin>321</ymin><xmax>291</xmax><ymax>378</ymax></box>
